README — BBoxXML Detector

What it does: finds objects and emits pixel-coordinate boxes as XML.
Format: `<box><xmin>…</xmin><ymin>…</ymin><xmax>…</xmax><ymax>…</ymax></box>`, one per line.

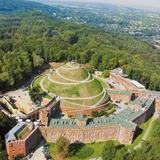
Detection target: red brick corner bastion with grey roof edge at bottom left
<box><xmin>5</xmin><ymin>122</ymin><xmax>40</xmax><ymax>160</ymax></box>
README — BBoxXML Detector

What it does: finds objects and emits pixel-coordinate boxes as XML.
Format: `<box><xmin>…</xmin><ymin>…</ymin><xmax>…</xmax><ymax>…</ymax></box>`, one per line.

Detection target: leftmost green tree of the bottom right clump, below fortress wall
<box><xmin>102</xmin><ymin>141</ymin><xmax>116</xmax><ymax>160</ymax></box>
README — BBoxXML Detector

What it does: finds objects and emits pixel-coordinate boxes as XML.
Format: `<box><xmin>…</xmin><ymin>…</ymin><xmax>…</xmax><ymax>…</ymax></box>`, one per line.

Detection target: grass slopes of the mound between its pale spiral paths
<box><xmin>33</xmin><ymin>66</ymin><xmax>108</xmax><ymax>107</ymax></box>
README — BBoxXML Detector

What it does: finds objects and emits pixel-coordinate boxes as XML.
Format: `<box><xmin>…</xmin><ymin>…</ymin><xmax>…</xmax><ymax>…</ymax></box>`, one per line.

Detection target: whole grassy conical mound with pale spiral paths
<box><xmin>33</xmin><ymin>64</ymin><xmax>108</xmax><ymax>107</ymax></box>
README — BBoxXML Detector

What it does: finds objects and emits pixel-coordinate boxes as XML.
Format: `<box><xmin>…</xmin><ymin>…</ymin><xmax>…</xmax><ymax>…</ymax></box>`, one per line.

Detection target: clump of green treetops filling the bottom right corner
<box><xmin>102</xmin><ymin>118</ymin><xmax>160</xmax><ymax>160</ymax></box>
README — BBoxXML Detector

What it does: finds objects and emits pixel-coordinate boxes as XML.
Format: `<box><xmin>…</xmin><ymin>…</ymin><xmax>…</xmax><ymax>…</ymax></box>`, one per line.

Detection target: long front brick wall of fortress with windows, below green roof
<box><xmin>40</xmin><ymin>124</ymin><xmax>134</xmax><ymax>144</ymax></box>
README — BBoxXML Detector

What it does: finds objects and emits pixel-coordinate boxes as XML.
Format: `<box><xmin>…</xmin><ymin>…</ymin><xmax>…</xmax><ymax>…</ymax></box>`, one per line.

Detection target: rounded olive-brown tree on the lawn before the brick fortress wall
<box><xmin>55</xmin><ymin>136</ymin><xmax>70</xmax><ymax>158</ymax></box>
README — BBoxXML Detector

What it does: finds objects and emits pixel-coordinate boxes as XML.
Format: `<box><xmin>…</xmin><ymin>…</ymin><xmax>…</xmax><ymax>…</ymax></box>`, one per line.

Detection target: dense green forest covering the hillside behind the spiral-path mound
<box><xmin>0</xmin><ymin>11</ymin><xmax>160</xmax><ymax>90</ymax></box>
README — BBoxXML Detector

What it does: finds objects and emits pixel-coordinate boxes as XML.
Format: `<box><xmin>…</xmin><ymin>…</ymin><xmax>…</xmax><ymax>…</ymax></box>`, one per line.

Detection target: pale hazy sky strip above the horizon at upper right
<box><xmin>61</xmin><ymin>0</ymin><xmax>160</xmax><ymax>8</ymax></box>
